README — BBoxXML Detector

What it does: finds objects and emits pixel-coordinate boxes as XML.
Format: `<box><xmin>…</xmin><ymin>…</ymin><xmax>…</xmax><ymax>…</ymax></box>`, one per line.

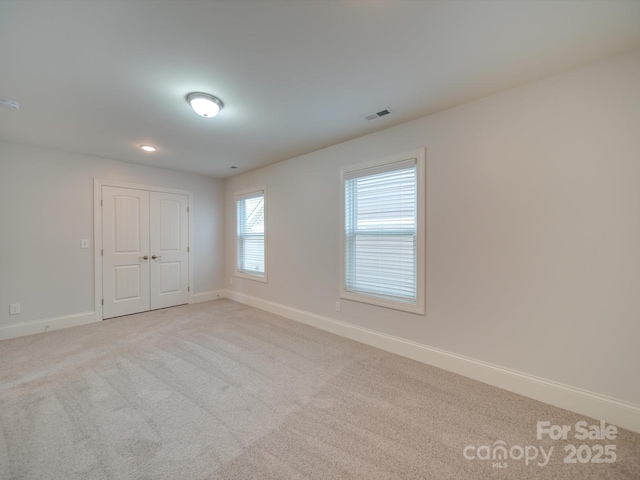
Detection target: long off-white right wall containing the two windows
<box><xmin>225</xmin><ymin>52</ymin><xmax>640</xmax><ymax>405</ymax></box>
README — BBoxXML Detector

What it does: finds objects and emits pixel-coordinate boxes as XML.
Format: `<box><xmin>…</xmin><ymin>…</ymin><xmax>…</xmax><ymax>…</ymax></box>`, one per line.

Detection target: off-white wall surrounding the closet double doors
<box><xmin>0</xmin><ymin>142</ymin><xmax>224</xmax><ymax>333</ymax></box>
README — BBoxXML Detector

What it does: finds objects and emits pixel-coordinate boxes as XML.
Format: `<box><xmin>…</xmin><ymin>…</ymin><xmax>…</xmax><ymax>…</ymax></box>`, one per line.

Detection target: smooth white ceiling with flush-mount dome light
<box><xmin>0</xmin><ymin>0</ymin><xmax>640</xmax><ymax>178</ymax></box>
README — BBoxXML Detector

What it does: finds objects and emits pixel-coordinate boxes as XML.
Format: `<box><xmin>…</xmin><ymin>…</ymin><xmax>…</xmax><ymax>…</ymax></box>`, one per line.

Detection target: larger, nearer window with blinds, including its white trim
<box><xmin>341</xmin><ymin>150</ymin><xmax>425</xmax><ymax>313</ymax></box>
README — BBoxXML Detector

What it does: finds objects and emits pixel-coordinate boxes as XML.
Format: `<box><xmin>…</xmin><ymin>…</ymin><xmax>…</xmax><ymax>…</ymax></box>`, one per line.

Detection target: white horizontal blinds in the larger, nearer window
<box><xmin>344</xmin><ymin>159</ymin><xmax>418</xmax><ymax>304</ymax></box>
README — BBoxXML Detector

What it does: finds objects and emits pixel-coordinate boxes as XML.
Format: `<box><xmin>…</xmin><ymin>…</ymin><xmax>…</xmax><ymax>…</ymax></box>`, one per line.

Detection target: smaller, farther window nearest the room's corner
<box><xmin>236</xmin><ymin>187</ymin><xmax>267</xmax><ymax>282</ymax></box>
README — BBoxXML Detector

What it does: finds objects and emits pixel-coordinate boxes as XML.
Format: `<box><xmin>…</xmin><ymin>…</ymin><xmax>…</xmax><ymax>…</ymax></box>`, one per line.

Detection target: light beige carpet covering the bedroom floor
<box><xmin>0</xmin><ymin>300</ymin><xmax>640</xmax><ymax>480</ymax></box>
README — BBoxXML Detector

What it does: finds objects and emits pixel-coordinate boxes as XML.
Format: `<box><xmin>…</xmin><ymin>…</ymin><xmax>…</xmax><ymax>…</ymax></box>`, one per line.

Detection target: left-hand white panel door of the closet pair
<box><xmin>102</xmin><ymin>186</ymin><xmax>151</xmax><ymax>318</ymax></box>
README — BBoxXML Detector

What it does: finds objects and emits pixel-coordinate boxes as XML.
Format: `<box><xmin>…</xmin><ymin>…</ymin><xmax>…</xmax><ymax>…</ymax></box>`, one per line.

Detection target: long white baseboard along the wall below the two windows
<box><xmin>224</xmin><ymin>290</ymin><xmax>640</xmax><ymax>433</ymax></box>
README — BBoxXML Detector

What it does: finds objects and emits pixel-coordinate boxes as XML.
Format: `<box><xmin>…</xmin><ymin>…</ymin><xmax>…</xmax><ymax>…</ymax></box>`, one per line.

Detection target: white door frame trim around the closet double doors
<box><xmin>93</xmin><ymin>178</ymin><xmax>194</xmax><ymax>320</ymax></box>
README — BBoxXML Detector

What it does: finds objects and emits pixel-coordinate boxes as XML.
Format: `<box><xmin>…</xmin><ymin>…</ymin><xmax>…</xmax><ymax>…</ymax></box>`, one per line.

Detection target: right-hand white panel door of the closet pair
<box><xmin>150</xmin><ymin>192</ymin><xmax>189</xmax><ymax>310</ymax></box>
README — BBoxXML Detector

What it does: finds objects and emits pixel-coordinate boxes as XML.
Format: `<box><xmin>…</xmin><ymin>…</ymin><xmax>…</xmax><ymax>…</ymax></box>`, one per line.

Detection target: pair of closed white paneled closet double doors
<box><xmin>102</xmin><ymin>186</ymin><xmax>189</xmax><ymax>318</ymax></box>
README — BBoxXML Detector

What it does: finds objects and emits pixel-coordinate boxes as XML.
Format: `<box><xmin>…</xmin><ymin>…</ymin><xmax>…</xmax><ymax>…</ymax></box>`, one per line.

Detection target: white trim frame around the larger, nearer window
<box><xmin>340</xmin><ymin>148</ymin><xmax>427</xmax><ymax>315</ymax></box>
